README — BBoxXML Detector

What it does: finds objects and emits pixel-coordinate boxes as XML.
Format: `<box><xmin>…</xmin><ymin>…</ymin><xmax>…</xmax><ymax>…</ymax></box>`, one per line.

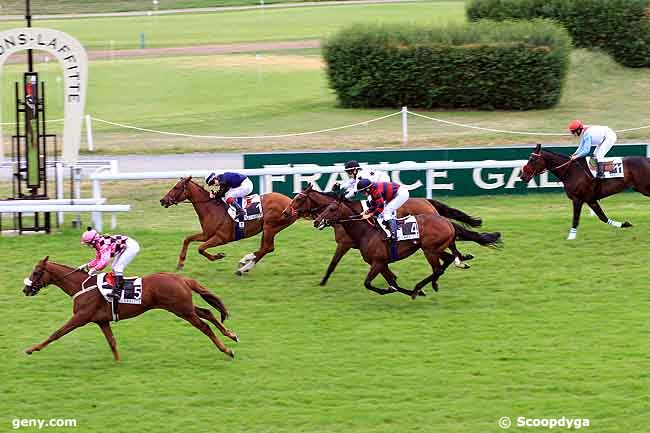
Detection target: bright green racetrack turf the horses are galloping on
<box><xmin>0</xmin><ymin>182</ymin><xmax>650</xmax><ymax>433</ymax></box>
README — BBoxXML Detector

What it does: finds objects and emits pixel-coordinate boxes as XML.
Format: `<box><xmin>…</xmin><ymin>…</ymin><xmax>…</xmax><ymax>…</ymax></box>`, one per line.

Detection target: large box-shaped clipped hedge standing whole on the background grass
<box><xmin>323</xmin><ymin>20</ymin><xmax>571</xmax><ymax>110</ymax></box>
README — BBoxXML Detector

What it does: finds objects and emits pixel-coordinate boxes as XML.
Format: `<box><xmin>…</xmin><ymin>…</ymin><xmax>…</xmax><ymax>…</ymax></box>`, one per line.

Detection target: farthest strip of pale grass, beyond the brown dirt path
<box><xmin>0</xmin><ymin>1</ymin><xmax>465</xmax><ymax>50</ymax></box>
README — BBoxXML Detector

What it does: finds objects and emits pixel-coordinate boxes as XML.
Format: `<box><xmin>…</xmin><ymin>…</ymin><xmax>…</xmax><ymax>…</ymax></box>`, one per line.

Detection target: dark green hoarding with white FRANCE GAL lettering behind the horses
<box><xmin>244</xmin><ymin>144</ymin><xmax>648</xmax><ymax>197</ymax></box>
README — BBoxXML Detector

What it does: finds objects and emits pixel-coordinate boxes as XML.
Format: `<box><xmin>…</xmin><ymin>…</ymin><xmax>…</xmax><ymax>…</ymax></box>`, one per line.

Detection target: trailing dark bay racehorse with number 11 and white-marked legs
<box><xmin>520</xmin><ymin>144</ymin><xmax>650</xmax><ymax>240</ymax></box>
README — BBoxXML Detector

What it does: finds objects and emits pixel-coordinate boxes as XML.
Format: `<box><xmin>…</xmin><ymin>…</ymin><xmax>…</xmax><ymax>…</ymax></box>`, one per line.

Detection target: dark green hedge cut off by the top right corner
<box><xmin>467</xmin><ymin>0</ymin><xmax>650</xmax><ymax>67</ymax></box>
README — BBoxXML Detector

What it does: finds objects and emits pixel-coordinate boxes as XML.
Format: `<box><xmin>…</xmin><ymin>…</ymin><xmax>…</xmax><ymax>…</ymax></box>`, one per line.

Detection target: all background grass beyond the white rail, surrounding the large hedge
<box><xmin>0</xmin><ymin>2</ymin><xmax>650</xmax><ymax>153</ymax></box>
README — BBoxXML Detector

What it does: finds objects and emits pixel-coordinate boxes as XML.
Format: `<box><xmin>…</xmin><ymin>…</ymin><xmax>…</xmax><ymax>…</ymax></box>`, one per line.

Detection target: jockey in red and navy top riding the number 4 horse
<box><xmin>357</xmin><ymin>179</ymin><xmax>409</xmax><ymax>240</ymax></box>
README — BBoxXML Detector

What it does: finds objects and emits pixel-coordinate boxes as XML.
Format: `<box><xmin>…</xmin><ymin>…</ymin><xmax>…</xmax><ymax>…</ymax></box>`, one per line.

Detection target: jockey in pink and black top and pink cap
<box><xmin>77</xmin><ymin>227</ymin><xmax>140</xmax><ymax>304</ymax></box>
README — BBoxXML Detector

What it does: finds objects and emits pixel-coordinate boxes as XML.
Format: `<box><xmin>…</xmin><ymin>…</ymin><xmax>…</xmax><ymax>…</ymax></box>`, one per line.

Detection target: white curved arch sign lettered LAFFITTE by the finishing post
<box><xmin>0</xmin><ymin>27</ymin><xmax>88</xmax><ymax>164</ymax></box>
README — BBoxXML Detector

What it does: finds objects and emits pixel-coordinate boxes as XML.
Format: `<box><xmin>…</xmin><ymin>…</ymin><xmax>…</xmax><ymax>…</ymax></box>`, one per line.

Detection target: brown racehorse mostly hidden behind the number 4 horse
<box><xmin>284</xmin><ymin>184</ymin><xmax>482</xmax><ymax>286</ymax></box>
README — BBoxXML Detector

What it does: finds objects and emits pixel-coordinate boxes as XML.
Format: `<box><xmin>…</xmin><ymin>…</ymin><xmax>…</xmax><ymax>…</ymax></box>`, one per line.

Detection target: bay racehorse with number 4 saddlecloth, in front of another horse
<box><xmin>314</xmin><ymin>200</ymin><xmax>501</xmax><ymax>299</ymax></box>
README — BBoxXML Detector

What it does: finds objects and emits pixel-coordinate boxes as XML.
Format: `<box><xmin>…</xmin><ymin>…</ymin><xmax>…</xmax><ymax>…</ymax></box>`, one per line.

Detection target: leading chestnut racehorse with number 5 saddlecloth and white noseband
<box><xmin>23</xmin><ymin>256</ymin><xmax>239</xmax><ymax>361</ymax></box>
